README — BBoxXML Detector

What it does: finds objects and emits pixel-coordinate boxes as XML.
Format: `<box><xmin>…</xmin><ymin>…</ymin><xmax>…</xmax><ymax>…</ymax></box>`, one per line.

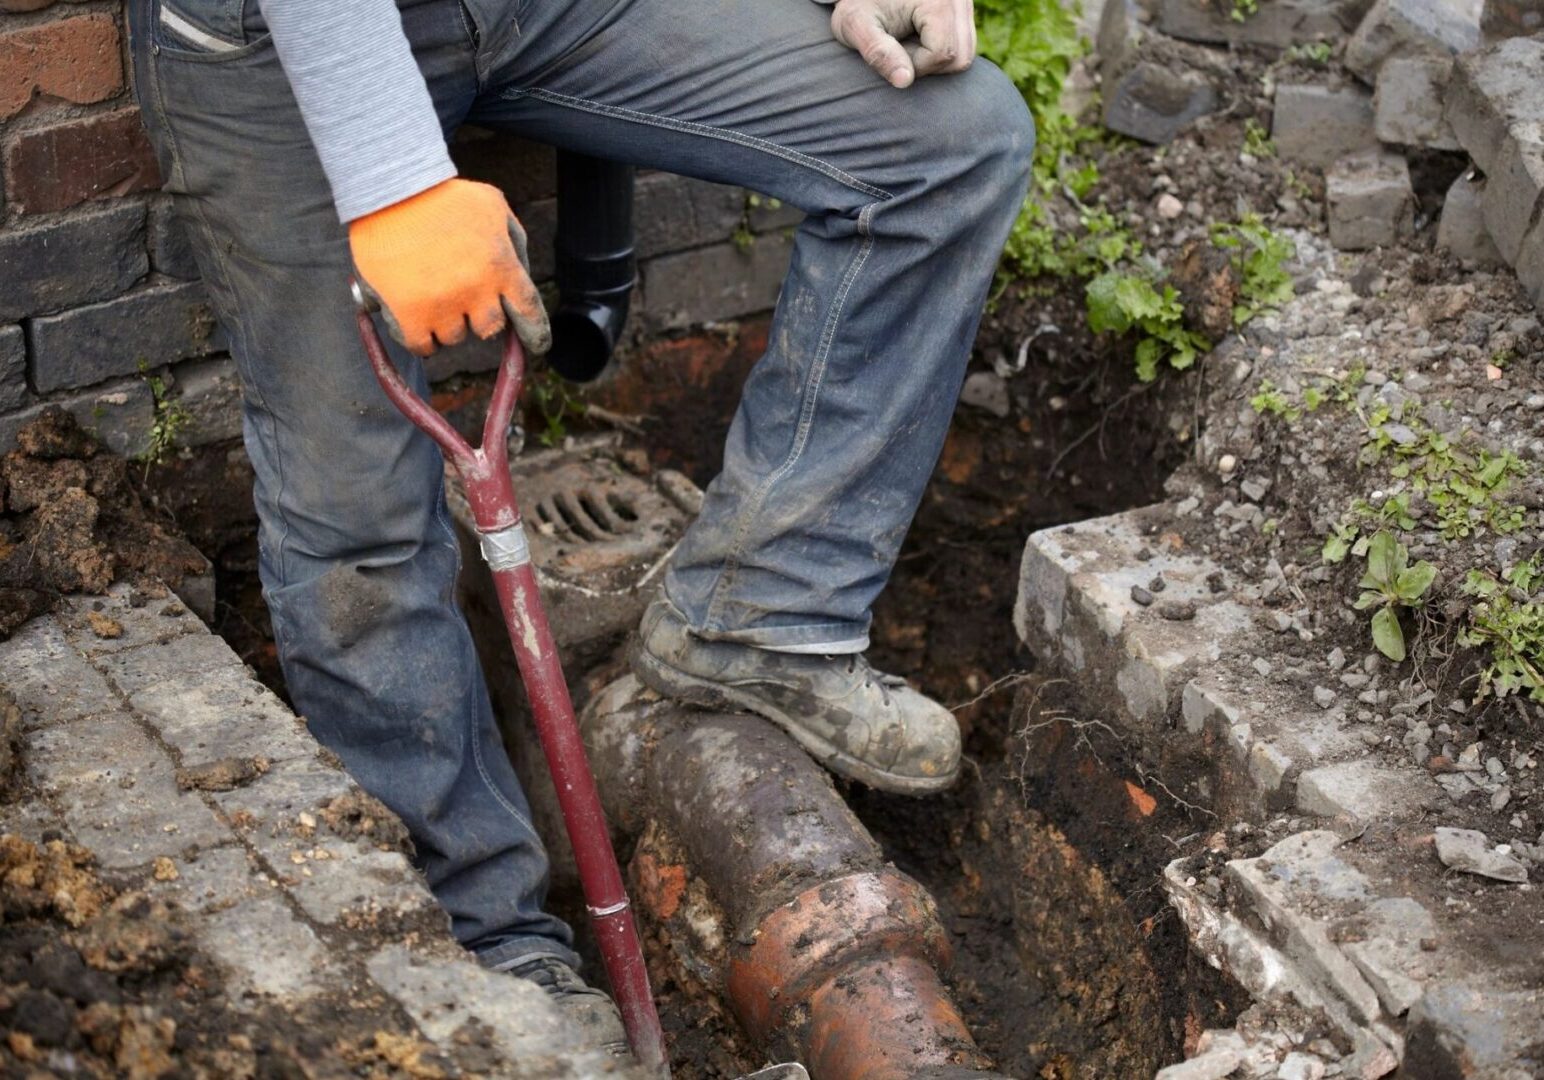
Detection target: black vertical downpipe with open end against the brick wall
<box><xmin>548</xmin><ymin>150</ymin><xmax>638</xmax><ymax>383</ymax></box>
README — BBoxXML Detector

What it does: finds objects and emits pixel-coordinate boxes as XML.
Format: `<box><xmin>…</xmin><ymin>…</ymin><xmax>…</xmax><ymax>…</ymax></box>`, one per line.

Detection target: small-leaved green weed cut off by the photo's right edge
<box><xmin>1458</xmin><ymin>555</ymin><xmax>1544</xmax><ymax>703</ymax></box>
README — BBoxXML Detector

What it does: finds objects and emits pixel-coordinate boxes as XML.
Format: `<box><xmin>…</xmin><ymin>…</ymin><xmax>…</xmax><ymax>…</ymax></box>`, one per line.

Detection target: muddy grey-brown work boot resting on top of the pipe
<box><xmin>633</xmin><ymin>599</ymin><xmax>960</xmax><ymax>796</ymax></box>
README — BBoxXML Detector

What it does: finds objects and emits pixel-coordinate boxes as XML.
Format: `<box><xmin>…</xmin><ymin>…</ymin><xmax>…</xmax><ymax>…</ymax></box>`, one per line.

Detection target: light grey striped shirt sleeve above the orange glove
<box><xmin>261</xmin><ymin>0</ymin><xmax>455</xmax><ymax>222</ymax></box>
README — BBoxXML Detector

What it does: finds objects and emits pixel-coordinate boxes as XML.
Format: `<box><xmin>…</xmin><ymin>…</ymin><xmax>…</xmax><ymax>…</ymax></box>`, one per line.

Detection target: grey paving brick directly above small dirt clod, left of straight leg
<box><xmin>128</xmin><ymin>663</ymin><xmax>317</xmax><ymax>765</ymax></box>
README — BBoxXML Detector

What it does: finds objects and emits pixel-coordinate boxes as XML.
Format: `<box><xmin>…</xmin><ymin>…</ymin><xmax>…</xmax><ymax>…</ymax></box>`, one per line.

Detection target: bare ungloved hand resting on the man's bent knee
<box><xmin>831</xmin><ymin>0</ymin><xmax>976</xmax><ymax>88</ymax></box>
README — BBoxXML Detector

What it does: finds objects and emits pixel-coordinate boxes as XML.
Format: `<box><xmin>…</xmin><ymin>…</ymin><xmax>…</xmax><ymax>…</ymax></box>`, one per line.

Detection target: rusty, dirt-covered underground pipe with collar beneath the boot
<box><xmin>581</xmin><ymin>677</ymin><xmax>996</xmax><ymax>1080</ymax></box>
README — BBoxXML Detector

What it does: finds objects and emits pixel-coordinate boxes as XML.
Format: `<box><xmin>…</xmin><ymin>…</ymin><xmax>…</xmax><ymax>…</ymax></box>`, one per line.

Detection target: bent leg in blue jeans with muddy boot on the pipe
<box><xmin>471</xmin><ymin>0</ymin><xmax>1033</xmax><ymax>791</ymax></box>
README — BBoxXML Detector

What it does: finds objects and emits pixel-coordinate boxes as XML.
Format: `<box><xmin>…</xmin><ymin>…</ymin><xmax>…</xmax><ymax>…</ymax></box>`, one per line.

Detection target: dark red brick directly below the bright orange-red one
<box><xmin>5</xmin><ymin>108</ymin><xmax>161</xmax><ymax>213</ymax></box>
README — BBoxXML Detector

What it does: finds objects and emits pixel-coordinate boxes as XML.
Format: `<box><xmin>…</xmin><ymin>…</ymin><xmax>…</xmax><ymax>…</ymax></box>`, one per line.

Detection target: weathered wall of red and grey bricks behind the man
<box><xmin>0</xmin><ymin>0</ymin><xmax>798</xmax><ymax>454</ymax></box>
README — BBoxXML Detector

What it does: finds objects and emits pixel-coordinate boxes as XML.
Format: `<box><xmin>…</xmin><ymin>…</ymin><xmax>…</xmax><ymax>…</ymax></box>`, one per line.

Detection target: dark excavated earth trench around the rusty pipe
<box><xmin>151</xmin><ymin>309</ymin><xmax>1244</xmax><ymax>1080</ymax></box>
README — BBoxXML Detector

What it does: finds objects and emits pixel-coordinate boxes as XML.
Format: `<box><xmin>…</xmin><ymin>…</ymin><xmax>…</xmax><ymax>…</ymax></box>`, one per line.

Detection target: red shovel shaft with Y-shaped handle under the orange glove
<box><xmin>358</xmin><ymin>304</ymin><xmax>667</xmax><ymax>1074</ymax></box>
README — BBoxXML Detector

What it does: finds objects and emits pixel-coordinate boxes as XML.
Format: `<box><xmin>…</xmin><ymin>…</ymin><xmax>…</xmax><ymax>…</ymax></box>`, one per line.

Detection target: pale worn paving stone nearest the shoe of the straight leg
<box><xmin>366</xmin><ymin>944</ymin><xmax>615</xmax><ymax>1077</ymax></box>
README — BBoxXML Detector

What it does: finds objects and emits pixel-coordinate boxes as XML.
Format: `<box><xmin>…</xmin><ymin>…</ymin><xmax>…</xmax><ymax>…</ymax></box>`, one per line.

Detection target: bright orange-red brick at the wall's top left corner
<box><xmin>0</xmin><ymin>14</ymin><xmax>124</xmax><ymax>121</ymax></box>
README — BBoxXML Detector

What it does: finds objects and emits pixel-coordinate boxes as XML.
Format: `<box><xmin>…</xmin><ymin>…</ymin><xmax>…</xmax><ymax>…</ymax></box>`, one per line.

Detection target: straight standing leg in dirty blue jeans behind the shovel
<box><xmin>130</xmin><ymin>0</ymin><xmax>576</xmax><ymax>964</ymax></box>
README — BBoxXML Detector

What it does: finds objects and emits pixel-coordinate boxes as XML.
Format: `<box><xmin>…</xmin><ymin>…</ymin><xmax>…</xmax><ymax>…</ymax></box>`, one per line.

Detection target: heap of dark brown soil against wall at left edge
<box><xmin>0</xmin><ymin>406</ymin><xmax>207</xmax><ymax>638</ymax></box>
